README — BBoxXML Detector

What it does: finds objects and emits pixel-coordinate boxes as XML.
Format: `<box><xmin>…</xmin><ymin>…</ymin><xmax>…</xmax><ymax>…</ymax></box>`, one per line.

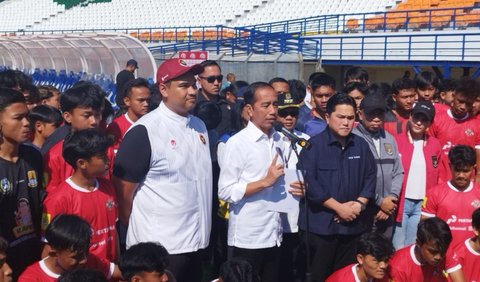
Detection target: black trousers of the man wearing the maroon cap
<box><xmin>168</xmin><ymin>250</ymin><xmax>205</xmax><ymax>282</ymax></box>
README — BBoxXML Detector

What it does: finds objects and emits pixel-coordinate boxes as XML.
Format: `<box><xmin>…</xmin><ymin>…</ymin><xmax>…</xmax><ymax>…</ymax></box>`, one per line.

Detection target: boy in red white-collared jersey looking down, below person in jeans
<box><xmin>382</xmin><ymin>217</ymin><xmax>452</xmax><ymax>282</ymax></box>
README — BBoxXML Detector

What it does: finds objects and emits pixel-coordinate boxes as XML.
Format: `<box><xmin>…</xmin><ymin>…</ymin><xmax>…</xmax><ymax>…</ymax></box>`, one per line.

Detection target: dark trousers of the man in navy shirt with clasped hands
<box><xmin>302</xmin><ymin>232</ymin><xmax>361</xmax><ymax>282</ymax></box>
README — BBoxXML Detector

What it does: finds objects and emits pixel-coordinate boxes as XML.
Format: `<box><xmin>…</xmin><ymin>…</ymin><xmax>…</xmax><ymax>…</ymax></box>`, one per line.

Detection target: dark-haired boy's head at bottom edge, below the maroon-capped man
<box><xmin>119</xmin><ymin>242</ymin><xmax>174</xmax><ymax>282</ymax></box>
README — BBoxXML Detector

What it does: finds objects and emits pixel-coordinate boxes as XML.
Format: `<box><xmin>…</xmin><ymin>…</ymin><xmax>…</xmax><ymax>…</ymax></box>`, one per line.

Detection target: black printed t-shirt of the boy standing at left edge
<box><xmin>0</xmin><ymin>145</ymin><xmax>46</xmax><ymax>278</ymax></box>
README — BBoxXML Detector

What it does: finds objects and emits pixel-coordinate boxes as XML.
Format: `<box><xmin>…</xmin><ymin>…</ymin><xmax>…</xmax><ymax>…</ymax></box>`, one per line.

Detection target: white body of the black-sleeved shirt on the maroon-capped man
<box><xmin>127</xmin><ymin>103</ymin><xmax>212</xmax><ymax>254</ymax></box>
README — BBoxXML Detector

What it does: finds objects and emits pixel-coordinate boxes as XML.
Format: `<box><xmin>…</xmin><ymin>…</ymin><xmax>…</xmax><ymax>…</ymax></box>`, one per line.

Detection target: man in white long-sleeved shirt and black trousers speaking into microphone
<box><xmin>218</xmin><ymin>82</ymin><xmax>284</xmax><ymax>282</ymax></box>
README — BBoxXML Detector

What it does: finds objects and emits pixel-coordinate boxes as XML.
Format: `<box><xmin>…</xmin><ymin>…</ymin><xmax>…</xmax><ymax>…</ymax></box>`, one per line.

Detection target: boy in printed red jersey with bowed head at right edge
<box><xmin>422</xmin><ymin>145</ymin><xmax>480</xmax><ymax>248</ymax></box>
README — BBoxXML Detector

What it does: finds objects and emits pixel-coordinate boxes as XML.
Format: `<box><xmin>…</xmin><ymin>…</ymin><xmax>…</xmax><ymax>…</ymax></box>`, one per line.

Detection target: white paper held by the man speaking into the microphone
<box><xmin>267</xmin><ymin>168</ymin><xmax>303</xmax><ymax>213</ymax></box>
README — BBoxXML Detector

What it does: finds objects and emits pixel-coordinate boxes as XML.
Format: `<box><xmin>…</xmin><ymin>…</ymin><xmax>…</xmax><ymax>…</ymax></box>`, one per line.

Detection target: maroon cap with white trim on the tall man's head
<box><xmin>157</xmin><ymin>58</ymin><xmax>203</xmax><ymax>83</ymax></box>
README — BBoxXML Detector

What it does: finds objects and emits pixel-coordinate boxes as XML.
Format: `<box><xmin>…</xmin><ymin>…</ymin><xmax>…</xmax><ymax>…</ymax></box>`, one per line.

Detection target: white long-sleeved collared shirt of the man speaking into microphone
<box><xmin>218</xmin><ymin>122</ymin><xmax>284</xmax><ymax>249</ymax></box>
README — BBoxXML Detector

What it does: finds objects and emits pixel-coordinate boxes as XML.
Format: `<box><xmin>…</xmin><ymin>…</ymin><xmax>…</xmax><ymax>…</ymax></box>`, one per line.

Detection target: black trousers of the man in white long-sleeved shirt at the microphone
<box><xmin>233</xmin><ymin>247</ymin><xmax>280</xmax><ymax>282</ymax></box>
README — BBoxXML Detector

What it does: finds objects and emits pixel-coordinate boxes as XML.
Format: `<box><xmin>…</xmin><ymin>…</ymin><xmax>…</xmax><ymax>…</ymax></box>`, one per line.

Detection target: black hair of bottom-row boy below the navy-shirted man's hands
<box><xmin>357</xmin><ymin>232</ymin><xmax>395</xmax><ymax>261</ymax></box>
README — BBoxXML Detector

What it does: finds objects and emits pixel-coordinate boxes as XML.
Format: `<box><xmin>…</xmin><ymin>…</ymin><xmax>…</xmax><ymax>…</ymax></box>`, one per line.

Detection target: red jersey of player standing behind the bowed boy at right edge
<box><xmin>429</xmin><ymin>109</ymin><xmax>480</xmax><ymax>182</ymax></box>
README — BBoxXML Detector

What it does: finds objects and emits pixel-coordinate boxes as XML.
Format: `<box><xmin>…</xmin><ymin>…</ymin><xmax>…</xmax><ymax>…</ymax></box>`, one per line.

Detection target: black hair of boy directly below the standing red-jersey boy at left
<box><xmin>45</xmin><ymin>214</ymin><xmax>92</xmax><ymax>252</ymax></box>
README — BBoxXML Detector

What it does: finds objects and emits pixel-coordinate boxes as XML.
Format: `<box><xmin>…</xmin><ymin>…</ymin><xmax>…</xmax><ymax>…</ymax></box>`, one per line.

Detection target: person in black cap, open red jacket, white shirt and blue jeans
<box><xmin>393</xmin><ymin>101</ymin><xmax>442</xmax><ymax>250</ymax></box>
